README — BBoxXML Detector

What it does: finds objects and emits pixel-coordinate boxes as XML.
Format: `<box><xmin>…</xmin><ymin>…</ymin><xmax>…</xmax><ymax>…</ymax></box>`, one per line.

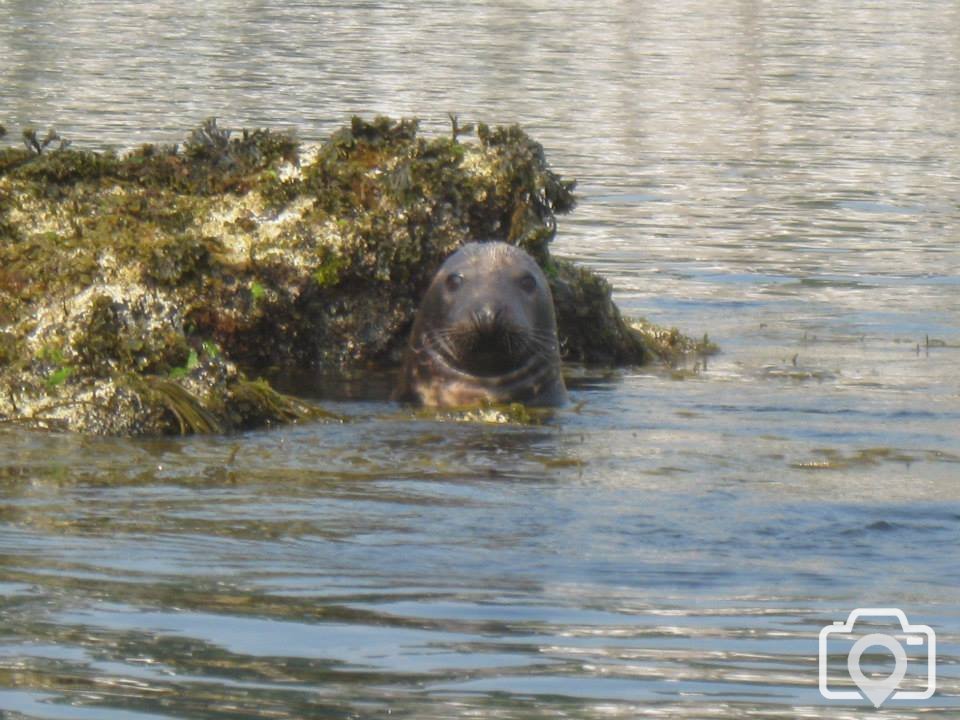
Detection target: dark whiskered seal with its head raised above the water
<box><xmin>395</xmin><ymin>242</ymin><xmax>567</xmax><ymax>407</ymax></box>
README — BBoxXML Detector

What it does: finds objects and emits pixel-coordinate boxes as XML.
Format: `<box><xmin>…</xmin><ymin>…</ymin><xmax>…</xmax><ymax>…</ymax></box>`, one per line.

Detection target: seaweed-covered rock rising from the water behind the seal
<box><xmin>0</xmin><ymin>118</ymin><xmax>693</xmax><ymax>434</ymax></box>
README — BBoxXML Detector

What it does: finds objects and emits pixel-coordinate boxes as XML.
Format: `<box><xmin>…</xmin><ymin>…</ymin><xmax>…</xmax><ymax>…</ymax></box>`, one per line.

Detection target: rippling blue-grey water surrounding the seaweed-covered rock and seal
<box><xmin>0</xmin><ymin>0</ymin><xmax>960</xmax><ymax>720</ymax></box>
